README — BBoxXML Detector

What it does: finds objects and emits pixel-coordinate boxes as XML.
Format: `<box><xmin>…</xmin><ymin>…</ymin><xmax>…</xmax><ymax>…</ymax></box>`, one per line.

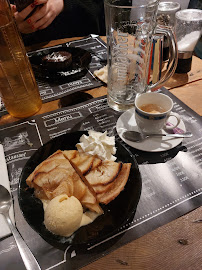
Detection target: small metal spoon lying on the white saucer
<box><xmin>123</xmin><ymin>131</ymin><xmax>192</xmax><ymax>142</ymax></box>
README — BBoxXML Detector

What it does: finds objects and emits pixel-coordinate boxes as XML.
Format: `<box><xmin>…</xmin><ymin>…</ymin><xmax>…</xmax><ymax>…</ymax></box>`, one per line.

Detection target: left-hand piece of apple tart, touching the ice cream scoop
<box><xmin>26</xmin><ymin>150</ymin><xmax>103</xmax><ymax>214</ymax></box>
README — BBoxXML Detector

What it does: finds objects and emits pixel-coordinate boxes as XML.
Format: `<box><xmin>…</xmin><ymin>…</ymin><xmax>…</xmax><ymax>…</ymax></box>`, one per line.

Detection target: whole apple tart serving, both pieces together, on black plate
<box><xmin>26</xmin><ymin>150</ymin><xmax>131</xmax><ymax>209</ymax></box>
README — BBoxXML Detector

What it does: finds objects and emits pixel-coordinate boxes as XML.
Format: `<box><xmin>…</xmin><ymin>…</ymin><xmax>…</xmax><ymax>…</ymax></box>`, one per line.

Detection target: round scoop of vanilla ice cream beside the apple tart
<box><xmin>44</xmin><ymin>194</ymin><xmax>83</xmax><ymax>236</ymax></box>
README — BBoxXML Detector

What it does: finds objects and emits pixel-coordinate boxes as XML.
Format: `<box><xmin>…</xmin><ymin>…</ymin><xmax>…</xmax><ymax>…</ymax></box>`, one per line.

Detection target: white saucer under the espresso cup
<box><xmin>116</xmin><ymin>108</ymin><xmax>186</xmax><ymax>152</ymax></box>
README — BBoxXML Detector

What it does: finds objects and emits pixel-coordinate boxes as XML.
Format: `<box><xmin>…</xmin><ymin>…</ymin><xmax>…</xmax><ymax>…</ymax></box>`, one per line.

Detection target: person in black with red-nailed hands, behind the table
<box><xmin>14</xmin><ymin>0</ymin><xmax>105</xmax><ymax>39</ymax></box>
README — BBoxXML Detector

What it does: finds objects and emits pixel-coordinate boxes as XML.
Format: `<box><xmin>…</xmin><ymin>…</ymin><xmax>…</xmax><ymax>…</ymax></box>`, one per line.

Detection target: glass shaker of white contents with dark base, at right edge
<box><xmin>175</xmin><ymin>9</ymin><xmax>202</xmax><ymax>73</ymax></box>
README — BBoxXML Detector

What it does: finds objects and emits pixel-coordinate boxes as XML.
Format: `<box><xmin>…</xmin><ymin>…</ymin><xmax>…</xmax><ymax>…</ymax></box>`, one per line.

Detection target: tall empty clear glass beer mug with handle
<box><xmin>105</xmin><ymin>0</ymin><xmax>177</xmax><ymax>111</ymax></box>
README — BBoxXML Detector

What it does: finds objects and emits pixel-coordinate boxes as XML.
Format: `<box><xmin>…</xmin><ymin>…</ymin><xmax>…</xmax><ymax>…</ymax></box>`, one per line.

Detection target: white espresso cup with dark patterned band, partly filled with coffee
<box><xmin>135</xmin><ymin>92</ymin><xmax>180</xmax><ymax>134</ymax></box>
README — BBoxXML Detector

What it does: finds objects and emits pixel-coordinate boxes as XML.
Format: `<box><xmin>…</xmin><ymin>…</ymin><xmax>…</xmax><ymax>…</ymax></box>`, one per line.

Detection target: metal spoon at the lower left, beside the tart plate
<box><xmin>0</xmin><ymin>185</ymin><xmax>41</xmax><ymax>270</ymax></box>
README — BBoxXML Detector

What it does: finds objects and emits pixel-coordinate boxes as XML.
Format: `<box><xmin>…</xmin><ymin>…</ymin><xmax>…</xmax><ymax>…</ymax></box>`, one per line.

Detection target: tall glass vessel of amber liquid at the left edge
<box><xmin>0</xmin><ymin>0</ymin><xmax>42</xmax><ymax>118</ymax></box>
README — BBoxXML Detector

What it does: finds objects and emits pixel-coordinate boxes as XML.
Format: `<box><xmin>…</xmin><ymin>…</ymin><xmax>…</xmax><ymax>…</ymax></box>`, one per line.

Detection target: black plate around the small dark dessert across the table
<box><xmin>29</xmin><ymin>46</ymin><xmax>91</xmax><ymax>82</ymax></box>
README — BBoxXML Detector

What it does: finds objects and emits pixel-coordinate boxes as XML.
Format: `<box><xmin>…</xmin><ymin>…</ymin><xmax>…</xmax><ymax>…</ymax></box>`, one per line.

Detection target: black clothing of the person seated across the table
<box><xmin>22</xmin><ymin>0</ymin><xmax>106</xmax><ymax>46</ymax></box>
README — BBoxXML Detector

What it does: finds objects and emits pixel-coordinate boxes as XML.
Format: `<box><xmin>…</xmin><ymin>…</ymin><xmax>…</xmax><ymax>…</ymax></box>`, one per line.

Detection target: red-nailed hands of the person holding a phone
<box><xmin>13</xmin><ymin>0</ymin><xmax>64</xmax><ymax>34</ymax></box>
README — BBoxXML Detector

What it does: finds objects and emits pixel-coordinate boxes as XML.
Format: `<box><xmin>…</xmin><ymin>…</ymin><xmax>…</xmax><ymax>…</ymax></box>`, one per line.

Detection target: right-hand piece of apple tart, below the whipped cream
<box><xmin>63</xmin><ymin>150</ymin><xmax>131</xmax><ymax>204</ymax></box>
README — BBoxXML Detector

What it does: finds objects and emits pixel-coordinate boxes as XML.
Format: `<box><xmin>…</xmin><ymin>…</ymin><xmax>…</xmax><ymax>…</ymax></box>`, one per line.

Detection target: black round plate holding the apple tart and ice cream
<box><xmin>18</xmin><ymin>131</ymin><xmax>142</xmax><ymax>248</ymax></box>
